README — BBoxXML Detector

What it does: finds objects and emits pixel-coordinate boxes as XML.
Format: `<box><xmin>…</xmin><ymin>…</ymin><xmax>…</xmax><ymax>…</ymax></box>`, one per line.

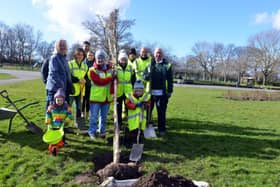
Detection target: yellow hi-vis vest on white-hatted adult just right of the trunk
<box><xmin>117</xmin><ymin>64</ymin><xmax>133</xmax><ymax>97</ymax></box>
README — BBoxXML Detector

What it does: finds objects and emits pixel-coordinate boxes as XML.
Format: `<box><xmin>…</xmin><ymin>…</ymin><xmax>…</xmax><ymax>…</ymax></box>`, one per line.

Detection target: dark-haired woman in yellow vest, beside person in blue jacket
<box><xmin>68</xmin><ymin>48</ymin><xmax>88</xmax><ymax>120</ymax></box>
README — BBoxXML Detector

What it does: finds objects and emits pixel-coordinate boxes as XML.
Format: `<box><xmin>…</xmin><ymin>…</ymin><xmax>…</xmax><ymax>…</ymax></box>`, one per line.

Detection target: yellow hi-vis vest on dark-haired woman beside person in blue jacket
<box><xmin>68</xmin><ymin>60</ymin><xmax>88</xmax><ymax>96</ymax></box>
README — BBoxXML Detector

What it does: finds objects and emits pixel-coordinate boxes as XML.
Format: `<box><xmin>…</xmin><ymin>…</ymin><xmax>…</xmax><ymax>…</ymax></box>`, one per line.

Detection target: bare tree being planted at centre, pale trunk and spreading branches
<box><xmin>83</xmin><ymin>9</ymin><xmax>134</xmax><ymax>163</ymax></box>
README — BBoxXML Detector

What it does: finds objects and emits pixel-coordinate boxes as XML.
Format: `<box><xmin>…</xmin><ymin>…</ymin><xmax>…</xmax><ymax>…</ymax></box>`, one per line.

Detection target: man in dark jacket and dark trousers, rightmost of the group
<box><xmin>143</xmin><ymin>48</ymin><xmax>173</xmax><ymax>136</ymax></box>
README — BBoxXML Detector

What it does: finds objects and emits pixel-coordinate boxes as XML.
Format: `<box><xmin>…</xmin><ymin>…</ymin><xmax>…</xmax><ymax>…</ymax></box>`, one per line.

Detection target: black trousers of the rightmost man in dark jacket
<box><xmin>151</xmin><ymin>95</ymin><xmax>168</xmax><ymax>132</ymax></box>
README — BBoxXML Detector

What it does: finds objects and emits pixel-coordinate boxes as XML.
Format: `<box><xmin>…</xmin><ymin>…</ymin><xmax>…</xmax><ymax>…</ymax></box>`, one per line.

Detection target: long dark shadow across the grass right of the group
<box><xmin>145</xmin><ymin>119</ymin><xmax>280</xmax><ymax>162</ymax></box>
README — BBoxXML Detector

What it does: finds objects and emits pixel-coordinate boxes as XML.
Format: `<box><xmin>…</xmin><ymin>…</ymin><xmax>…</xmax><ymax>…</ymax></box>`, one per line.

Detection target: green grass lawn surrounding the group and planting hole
<box><xmin>0</xmin><ymin>80</ymin><xmax>280</xmax><ymax>187</ymax></box>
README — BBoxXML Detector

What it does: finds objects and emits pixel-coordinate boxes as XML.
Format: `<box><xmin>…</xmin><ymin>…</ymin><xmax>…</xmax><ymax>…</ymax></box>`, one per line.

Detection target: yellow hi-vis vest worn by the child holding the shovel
<box><xmin>127</xmin><ymin>93</ymin><xmax>151</xmax><ymax>131</ymax></box>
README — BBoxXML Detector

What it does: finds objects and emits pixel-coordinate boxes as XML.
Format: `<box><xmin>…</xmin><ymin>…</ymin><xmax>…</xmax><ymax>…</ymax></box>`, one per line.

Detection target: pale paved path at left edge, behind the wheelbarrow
<box><xmin>0</xmin><ymin>69</ymin><xmax>41</xmax><ymax>84</ymax></box>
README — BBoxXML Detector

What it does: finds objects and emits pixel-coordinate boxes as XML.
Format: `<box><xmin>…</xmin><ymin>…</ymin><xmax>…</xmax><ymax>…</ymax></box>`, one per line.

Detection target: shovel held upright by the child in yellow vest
<box><xmin>129</xmin><ymin>106</ymin><xmax>144</xmax><ymax>162</ymax></box>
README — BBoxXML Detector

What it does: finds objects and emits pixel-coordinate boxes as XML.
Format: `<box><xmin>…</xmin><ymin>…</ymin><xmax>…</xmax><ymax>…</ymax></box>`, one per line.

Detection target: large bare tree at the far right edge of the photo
<box><xmin>249</xmin><ymin>30</ymin><xmax>280</xmax><ymax>85</ymax></box>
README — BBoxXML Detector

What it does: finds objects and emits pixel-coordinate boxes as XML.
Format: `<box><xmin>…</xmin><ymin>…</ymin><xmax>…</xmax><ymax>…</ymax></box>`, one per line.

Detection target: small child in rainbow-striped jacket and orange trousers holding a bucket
<box><xmin>45</xmin><ymin>88</ymin><xmax>73</xmax><ymax>156</ymax></box>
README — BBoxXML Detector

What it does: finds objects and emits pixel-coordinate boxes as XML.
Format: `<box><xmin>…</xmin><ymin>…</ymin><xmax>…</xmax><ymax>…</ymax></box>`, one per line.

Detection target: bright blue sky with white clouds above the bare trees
<box><xmin>0</xmin><ymin>0</ymin><xmax>280</xmax><ymax>56</ymax></box>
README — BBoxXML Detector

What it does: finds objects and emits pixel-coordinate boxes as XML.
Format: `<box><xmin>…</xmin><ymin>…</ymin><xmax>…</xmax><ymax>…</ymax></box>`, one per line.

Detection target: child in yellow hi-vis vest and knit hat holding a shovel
<box><xmin>125</xmin><ymin>80</ymin><xmax>151</xmax><ymax>146</ymax></box>
